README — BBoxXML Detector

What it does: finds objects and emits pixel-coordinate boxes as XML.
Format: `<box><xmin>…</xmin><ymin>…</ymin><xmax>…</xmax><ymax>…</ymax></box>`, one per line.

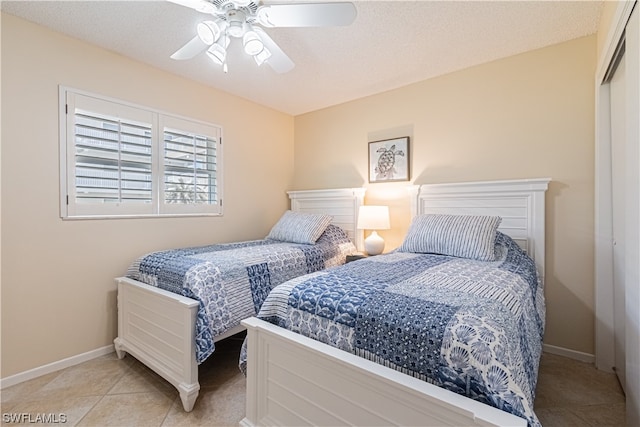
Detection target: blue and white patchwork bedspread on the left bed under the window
<box><xmin>127</xmin><ymin>225</ymin><xmax>355</xmax><ymax>363</ymax></box>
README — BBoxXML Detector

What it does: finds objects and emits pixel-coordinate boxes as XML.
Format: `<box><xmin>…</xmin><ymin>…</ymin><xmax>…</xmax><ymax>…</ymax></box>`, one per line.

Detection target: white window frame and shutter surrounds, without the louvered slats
<box><xmin>58</xmin><ymin>86</ymin><xmax>223</xmax><ymax>220</ymax></box>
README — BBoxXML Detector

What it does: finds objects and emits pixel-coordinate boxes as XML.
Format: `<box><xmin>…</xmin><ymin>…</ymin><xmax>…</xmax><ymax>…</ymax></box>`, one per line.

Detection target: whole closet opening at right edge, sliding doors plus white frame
<box><xmin>595</xmin><ymin>0</ymin><xmax>640</xmax><ymax>426</ymax></box>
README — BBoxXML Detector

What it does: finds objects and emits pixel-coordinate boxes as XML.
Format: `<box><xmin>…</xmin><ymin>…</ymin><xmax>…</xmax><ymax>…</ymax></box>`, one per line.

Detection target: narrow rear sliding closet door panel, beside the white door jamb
<box><xmin>609</xmin><ymin>52</ymin><xmax>627</xmax><ymax>389</ymax></box>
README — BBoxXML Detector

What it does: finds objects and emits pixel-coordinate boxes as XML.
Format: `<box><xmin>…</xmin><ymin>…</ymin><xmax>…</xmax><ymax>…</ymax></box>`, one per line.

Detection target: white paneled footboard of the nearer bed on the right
<box><xmin>241</xmin><ymin>318</ymin><xmax>527</xmax><ymax>427</ymax></box>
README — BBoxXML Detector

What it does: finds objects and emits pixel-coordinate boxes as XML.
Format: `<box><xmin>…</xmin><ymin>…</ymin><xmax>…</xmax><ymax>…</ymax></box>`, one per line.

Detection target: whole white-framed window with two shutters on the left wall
<box><xmin>60</xmin><ymin>88</ymin><xmax>222</xmax><ymax>218</ymax></box>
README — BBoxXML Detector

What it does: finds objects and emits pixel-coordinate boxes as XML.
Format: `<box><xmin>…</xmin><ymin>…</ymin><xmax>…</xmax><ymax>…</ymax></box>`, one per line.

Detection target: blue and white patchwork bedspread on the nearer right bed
<box><xmin>241</xmin><ymin>233</ymin><xmax>545</xmax><ymax>426</ymax></box>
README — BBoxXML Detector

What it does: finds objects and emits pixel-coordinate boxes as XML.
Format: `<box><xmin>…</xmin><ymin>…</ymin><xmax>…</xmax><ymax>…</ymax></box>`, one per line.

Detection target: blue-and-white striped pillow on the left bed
<box><xmin>267</xmin><ymin>211</ymin><xmax>332</xmax><ymax>244</ymax></box>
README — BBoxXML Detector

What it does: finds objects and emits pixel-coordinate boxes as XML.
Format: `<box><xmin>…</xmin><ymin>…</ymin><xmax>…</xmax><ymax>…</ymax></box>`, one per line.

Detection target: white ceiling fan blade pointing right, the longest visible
<box><xmin>257</xmin><ymin>2</ymin><xmax>357</xmax><ymax>27</ymax></box>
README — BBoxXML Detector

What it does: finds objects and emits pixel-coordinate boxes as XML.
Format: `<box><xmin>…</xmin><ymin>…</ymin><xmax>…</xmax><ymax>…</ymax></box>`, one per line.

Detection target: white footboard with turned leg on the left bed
<box><xmin>114</xmin><ymin>277</ymin><xmax>200</xmax><ymax>412</ymax></box>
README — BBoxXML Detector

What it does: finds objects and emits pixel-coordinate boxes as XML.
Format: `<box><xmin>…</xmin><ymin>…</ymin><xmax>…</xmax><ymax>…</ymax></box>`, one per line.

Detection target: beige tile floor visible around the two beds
<box><xmin>1</xmin><ymin>337</ymin><xmax>625</xmax><ymax>427</ymax></box>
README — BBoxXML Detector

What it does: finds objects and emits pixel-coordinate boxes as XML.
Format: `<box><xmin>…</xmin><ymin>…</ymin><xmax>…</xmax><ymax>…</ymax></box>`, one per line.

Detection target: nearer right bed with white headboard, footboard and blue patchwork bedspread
<box><xmin>242</xmin><ymin>179</ymin><xmax>549</xmax><ymax>426</ymax></box>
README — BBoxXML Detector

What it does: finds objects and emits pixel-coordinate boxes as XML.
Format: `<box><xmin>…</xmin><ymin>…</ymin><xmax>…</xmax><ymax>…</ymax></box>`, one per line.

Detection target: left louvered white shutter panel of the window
<box><xmin>63</xmin><ymin>92</ymin><xmax>156</xmax><ymax>217</ymax></box>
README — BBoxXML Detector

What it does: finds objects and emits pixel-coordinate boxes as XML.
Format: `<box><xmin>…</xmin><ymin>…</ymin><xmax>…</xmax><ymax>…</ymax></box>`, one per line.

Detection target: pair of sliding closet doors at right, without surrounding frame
<box><xmin>609</xmin><ymin>5</ymin><xmax>640</xmax><ymax>425</ymax></box>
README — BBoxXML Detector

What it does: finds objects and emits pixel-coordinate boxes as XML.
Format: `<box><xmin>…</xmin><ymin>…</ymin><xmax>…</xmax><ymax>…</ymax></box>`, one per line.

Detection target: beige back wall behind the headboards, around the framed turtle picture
<box><xmin>294</xmin><ymin>36</ymin><xmax>597</xmax><ymax>354</ymax></box>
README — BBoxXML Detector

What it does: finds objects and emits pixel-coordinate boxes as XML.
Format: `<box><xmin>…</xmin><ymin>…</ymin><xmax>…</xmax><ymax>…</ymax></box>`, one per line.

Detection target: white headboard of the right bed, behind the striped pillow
<box><xmin>412</xmin><ymin>178</ymin><xmax>551</xmax><ymax>277</ymax></box>
